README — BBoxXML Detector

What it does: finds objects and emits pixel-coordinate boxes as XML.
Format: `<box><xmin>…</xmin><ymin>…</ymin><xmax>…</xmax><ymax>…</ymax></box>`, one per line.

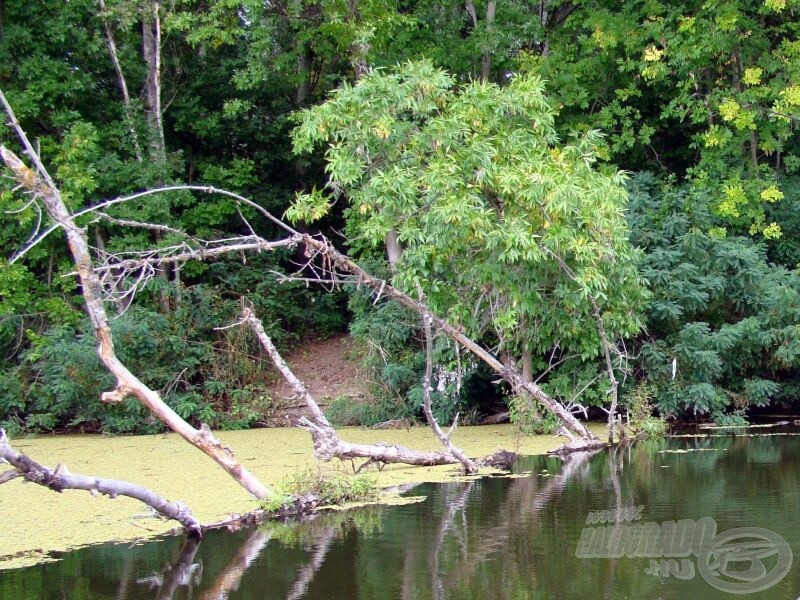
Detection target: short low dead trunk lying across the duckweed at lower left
<box><xmin>0</xmin><ymin>429</ymin><xmax>203</xmax><ymax>537</ymax></box>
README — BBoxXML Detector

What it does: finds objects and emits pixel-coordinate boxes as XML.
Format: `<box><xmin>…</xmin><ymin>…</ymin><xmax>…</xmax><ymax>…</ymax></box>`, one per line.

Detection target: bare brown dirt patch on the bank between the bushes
<box><xmin>267</xmin><ymin>335</ymin><xmax>369</xmax><ymax>426</ymax></box>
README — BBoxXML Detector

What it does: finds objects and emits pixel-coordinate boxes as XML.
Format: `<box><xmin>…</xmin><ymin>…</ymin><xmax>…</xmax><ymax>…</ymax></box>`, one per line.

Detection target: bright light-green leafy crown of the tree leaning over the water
<box><xmin>288</xmin><ymin>61</ymin><xmax>645</xmax><ymax>434</ymax></box>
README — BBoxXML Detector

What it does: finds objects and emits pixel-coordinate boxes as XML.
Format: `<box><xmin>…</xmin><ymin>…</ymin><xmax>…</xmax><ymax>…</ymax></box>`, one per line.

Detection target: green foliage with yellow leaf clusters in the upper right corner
<box><xmin>530</xmin><ymin>0</ymin><xmax>800</xmax><ymax>239</ymax></box>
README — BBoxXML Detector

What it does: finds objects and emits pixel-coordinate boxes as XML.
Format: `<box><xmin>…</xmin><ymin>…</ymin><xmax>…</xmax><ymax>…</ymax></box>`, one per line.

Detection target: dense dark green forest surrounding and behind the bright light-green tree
<box><xmin>0</xmin><ymin>0</ymin><xmax>800</xmax><ymax>432</ymax></box>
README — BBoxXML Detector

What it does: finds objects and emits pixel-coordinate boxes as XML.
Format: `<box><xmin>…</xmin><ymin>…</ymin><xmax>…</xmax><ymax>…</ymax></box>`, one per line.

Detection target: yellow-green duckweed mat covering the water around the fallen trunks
<box><xmin>0</xmin><ymin>424</ymin><xmax>602</xmax><ymax>569</ymax></box>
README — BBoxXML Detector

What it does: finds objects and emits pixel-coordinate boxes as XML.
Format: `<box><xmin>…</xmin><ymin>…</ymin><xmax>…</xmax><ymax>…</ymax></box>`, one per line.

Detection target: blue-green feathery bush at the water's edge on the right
<box><xmin>630</xmin><ymin>175</ymin><xmax>800</xmax><ymax>419</ymax></box>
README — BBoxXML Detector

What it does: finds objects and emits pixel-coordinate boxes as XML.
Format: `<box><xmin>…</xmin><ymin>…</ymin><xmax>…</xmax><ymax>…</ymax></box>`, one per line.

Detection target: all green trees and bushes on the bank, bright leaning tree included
<box><xmin>0</xmin><ymin>0</ymin><xmax>800</xmax><ymax>431</ymax></box>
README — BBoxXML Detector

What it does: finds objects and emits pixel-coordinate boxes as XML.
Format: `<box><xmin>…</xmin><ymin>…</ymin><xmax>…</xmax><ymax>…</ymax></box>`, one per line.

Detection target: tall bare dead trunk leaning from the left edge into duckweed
<box><xmin>0</xmin><ymin>91</ymin><xmax>272</xmax><ymax>499</ymax></box>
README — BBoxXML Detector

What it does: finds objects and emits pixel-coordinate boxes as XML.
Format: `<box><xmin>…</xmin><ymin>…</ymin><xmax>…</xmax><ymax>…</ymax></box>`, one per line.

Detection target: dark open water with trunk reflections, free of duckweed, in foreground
<box><xmin>0</xmin><ymin>430</ymin><xmax>800</xmax><ymax>600</ymax></box>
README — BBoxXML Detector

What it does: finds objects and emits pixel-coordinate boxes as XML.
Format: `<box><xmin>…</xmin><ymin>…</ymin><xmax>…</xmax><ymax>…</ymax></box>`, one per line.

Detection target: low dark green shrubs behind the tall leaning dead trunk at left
<box><xmin>0</xmin><ymin>298</ymin><xmax>270</xmax><ymax>433</ymax></box>
